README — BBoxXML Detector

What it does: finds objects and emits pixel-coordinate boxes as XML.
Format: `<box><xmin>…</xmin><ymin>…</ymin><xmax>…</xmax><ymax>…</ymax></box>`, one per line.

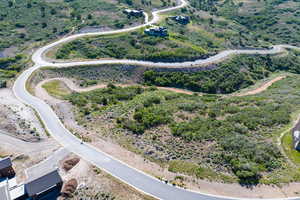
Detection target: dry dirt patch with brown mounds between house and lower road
<box><xmin>61</xmin><ymin>155</ymin><xmax>156</xmax><ymax>200</ymax></box>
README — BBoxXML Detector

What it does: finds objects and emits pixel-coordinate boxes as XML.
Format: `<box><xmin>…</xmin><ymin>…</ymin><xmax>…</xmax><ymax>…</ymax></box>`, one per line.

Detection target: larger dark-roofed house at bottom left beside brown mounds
<box><xmin>25</xmin><ymin>169</ymin><xmax>63</xmax><ymax>199</ymax></box>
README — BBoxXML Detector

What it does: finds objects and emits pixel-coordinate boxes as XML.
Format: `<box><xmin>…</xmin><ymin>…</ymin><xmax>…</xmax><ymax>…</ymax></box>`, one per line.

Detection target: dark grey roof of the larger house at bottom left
<box><xmin>25</xmin><ymin>170</ymin><xmax>62</xmax><ymax>197</ymax></box>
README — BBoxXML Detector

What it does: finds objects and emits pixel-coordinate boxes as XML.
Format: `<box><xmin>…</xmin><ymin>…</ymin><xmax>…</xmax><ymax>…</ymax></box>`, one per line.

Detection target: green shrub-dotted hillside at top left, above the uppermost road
<box><xmin>0</xmin><ymin>0</ymin><xmax>173</xmax><ymax>51</ymax></box>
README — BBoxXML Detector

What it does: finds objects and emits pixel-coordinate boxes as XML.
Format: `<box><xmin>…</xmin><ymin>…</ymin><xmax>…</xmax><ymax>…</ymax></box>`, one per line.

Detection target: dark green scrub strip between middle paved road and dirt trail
<box><xmin>42</xmin><ymin>51</ymin><xmax>300</xmax><ymax>94</ymax></box>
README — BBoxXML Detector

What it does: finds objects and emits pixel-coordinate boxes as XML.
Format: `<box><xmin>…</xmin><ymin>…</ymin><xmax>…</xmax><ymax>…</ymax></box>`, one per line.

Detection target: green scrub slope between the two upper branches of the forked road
<box><xmin>55</xmin><ymin>0</ymin><xmax>300</xmax><ymax>62</ymax></box>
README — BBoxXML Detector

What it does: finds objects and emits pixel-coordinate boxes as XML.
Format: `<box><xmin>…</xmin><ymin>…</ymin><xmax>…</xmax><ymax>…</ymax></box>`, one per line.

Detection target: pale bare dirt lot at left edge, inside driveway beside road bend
<box><xmin>0</xmin><ymin>89</ymin><xmax>60</xmax><ymax>182</ymax></box>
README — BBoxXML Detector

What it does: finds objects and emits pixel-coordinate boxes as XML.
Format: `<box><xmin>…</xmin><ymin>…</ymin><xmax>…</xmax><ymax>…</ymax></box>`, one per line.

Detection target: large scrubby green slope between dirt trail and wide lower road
<box><xmin>66</xmin><ymin>75</ymin><xmax>300</xmax><ymax>184</ymax></box>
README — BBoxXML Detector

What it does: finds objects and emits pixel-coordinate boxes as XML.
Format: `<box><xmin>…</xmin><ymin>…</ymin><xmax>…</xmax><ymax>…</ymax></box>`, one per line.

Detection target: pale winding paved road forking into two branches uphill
<box><xmin>13</xmin><ymin>0</ymin><xmax>299</xmax><ymax>200</ymax></box>
